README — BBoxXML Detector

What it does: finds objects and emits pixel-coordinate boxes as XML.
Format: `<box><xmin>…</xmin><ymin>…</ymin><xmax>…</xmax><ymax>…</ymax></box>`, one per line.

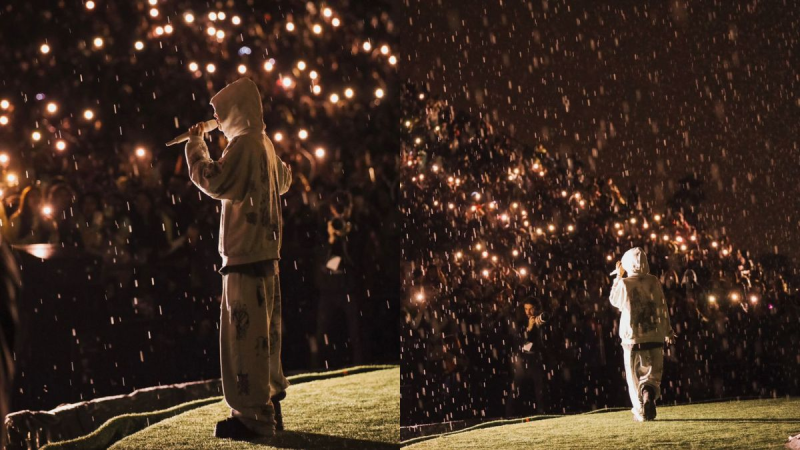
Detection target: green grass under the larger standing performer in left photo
<box><xmin>111</xmin><ymin>368</ymin><xmax>400</xmax><ymax>450</ymax></box>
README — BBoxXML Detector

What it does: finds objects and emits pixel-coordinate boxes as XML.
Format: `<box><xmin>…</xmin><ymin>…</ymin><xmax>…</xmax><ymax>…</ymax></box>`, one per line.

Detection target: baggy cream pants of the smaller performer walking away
<box><xmin>622</xmin><ymin>345</ymin><xmax>664</xmax><ymax>416</ymax></box>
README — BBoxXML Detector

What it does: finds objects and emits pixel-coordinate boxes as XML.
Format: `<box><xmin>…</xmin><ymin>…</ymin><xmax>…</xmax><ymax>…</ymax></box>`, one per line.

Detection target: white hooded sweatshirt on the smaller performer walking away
<box><xmin>609</xmin><ymin>247</ymin><xmax>672</xmax><ymax>345</ymax></box>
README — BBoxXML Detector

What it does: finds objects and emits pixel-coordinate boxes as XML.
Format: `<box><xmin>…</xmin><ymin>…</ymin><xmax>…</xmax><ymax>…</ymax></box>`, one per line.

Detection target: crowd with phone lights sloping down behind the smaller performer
<box><xmin>399</xmin><ymin>85</ymin><xmax>800</xmax><ymax>425</ymax></box>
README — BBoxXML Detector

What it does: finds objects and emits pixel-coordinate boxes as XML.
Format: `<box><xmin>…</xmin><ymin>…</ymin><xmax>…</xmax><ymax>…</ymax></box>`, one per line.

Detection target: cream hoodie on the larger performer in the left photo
<box><xmin>186</xmin><ymin>78</ymin><xmax>292</xmax><ymax>267</ymax></box>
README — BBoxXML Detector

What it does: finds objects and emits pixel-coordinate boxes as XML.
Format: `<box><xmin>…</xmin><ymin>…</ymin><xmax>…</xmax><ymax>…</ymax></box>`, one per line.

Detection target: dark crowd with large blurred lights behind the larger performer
<box><xmin>0</xmin><ymin>1</ymin><xmax>400</xmax><ymax>409</ymax></box>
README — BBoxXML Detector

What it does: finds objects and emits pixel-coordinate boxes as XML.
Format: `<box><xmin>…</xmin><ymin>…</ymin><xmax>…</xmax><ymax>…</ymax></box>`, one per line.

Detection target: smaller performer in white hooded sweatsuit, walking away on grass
<box><xmin>609</xmin><ymin>247</ymin><xmax>675</xmax><ymax>422</ymax></box>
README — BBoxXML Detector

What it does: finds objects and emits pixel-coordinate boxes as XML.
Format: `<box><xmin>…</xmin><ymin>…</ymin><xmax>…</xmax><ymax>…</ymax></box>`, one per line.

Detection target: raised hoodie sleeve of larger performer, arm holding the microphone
<box><xmin>186</xmin><ymin>136</ymin><xmax>253</xmax><ymax>201</ymax></box>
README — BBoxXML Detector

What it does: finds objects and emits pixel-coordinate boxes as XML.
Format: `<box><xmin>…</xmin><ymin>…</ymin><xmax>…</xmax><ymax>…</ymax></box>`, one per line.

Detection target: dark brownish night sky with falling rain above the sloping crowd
<box><xmin>398</xmin><ymin>0</ymin><xmax>800</xmax><ymax>261</ymax></box>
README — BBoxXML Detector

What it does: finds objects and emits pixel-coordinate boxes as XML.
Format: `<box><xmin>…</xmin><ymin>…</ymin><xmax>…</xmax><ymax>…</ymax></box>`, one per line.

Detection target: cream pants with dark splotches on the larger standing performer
<box><xmin>219</xmin><ymin>271</ymin><xmax>289</xmax><ymax>436</ymax></box>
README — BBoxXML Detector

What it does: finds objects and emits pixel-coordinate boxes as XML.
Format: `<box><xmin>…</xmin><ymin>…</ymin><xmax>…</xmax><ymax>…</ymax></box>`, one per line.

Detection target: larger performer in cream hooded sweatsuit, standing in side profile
<box><xmin>186</xmin><ymin>78</ymin><xmax>292</xmax><ymax>439</ymax></box>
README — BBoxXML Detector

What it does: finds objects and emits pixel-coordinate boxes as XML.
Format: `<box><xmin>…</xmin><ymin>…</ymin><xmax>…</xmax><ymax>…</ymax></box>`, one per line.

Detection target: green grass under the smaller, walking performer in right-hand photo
<box><xmin>405</xmin><ymin>398</ymin><xmax>800</xmax><ymax>450</ymax></box>
